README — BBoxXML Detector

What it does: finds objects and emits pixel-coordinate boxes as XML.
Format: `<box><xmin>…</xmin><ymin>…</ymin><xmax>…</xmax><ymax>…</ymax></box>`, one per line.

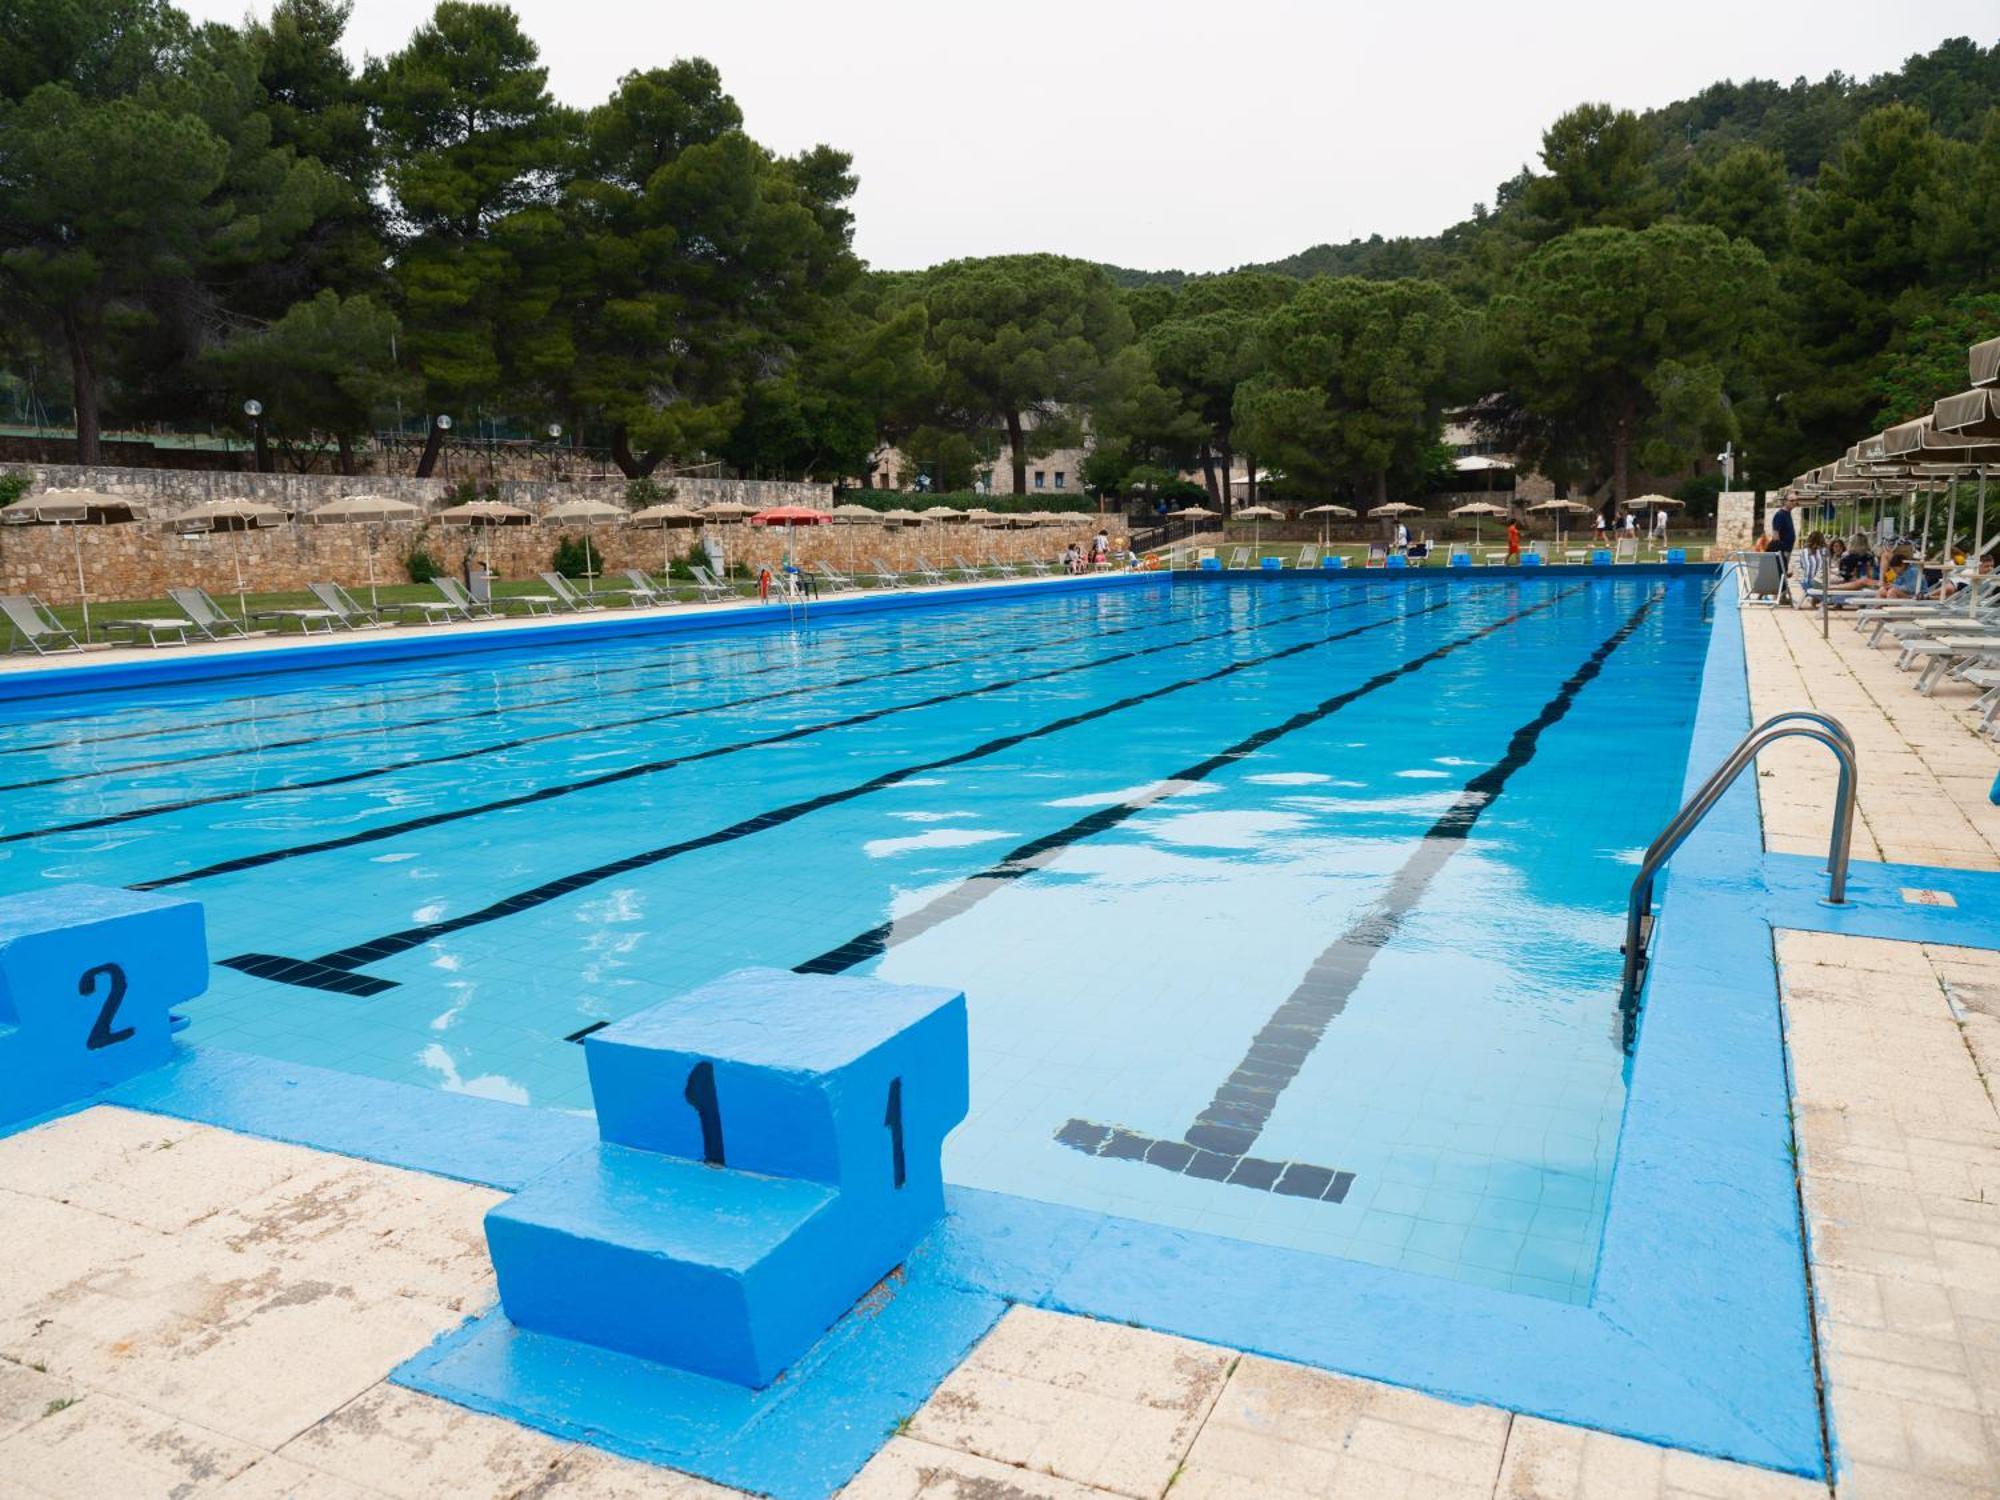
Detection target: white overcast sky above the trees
<box><xmin>178</xmin><ymin>0</ymin><xmax>2000</xmax><ymax>270</ymax></box>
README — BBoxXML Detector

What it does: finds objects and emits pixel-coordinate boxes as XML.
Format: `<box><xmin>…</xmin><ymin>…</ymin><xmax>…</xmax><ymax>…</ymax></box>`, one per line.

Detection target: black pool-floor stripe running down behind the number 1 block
<box><xmin>792</xmin><ymin>586</ymin><xmax>1580</xmax><ymax>974</ymax></box>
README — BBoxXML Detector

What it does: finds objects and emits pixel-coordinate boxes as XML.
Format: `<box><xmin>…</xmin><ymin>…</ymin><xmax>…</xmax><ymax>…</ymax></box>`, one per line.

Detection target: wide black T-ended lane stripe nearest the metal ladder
<box><xmin>1056</xmin><ymin>594</ymin><xmax>1660</xmax><ymax>1204</ymax></box>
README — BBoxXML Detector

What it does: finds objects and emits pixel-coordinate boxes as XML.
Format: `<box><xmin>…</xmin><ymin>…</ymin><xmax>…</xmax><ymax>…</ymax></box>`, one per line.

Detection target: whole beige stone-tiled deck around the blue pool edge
<box><xmin>0</xmin><ymin>580</ymin><xmax>2000</xmax><ymax>1500</ymax></box>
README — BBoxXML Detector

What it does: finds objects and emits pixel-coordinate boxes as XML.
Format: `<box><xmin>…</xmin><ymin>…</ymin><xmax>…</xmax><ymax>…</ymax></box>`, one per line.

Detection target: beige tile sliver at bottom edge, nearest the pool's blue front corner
<box><xmin>1494</xmin><ymin>1416</ymin><xmax>1826</xmax><ymax>1500</ymax></box>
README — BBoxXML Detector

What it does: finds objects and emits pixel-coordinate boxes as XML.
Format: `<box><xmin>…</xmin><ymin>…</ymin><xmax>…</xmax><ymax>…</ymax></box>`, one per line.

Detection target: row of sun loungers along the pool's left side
<box><xmin>0</xmin><ymin>556</ymin><xmax>1054</xmax><ymax>656</ymax></box>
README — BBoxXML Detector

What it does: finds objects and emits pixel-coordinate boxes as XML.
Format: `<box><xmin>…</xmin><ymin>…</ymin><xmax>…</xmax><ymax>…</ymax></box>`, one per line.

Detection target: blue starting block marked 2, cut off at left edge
<box><xmin>0</xmin><ymin>886</ymin><xmax>208</xmax><ymax>1126</ymax></box>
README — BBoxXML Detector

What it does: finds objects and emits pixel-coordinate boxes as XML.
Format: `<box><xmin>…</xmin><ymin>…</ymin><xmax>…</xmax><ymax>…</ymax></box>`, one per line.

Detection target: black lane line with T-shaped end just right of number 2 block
<box><xmin>220</xmin><ymin>590</ymin><xmax>1448</xmax><ymax>996</ymax></box>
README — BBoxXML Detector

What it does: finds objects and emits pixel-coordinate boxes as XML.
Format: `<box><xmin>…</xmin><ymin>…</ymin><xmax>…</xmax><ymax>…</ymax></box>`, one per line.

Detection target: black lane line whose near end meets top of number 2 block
<box><xmin>137</xmin><ymin>604</ymin><xmax>1354</xmax><ymax>890</ymax></box>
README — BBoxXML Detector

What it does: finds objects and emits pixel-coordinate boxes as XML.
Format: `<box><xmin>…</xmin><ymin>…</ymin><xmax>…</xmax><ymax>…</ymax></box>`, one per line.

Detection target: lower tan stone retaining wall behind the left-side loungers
<box><xmin>0</xmin><ymin>516</ymin><xmax>1096</xmax><ymax>604</ymax></box>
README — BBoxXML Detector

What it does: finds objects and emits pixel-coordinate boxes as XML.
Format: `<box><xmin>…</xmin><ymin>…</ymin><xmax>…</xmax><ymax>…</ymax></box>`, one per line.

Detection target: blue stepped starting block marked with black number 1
<box><xmin>486</xmin><ymin>970</ymin><xmax>968</xmax><ymax>1388</ymax></box>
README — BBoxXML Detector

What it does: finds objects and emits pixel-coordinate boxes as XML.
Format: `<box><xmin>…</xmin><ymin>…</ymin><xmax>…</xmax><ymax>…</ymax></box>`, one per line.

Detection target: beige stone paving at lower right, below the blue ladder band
<box><xmin>1778</xmin><ymin>932</ymin><xmax>2000</xmax><ymax>1500</ymax></box>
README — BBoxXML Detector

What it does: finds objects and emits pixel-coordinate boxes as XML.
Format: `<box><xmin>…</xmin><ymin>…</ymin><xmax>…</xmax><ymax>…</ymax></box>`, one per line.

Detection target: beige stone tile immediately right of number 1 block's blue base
<box><xmin>910</xmin><ymin>1308</ymin><xmax>1234</xmax><ymax>1496</ymax></box>
